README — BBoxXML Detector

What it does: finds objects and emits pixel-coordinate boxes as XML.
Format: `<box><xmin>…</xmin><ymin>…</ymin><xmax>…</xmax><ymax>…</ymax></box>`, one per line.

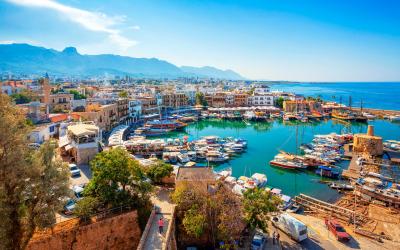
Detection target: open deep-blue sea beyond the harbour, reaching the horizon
<box><xmin>271</xmin><ymin>82</ymin><xmax>400</xmax><ymax>110</ymax></box>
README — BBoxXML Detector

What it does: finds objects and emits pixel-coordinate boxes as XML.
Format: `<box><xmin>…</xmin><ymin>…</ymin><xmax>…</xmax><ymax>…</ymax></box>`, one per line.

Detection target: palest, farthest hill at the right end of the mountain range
<box><xmin>181</xmin><ymin>66</ymin><xmax>245</xmax><ymax>80</ymax></box>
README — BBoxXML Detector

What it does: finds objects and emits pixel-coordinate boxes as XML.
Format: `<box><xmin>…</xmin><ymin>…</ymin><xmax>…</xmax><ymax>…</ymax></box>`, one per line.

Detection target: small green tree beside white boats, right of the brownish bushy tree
<box><xmin>243</xmin><ymin>188</ymin><xmax>280</xmax><ymax>232</ymax></box>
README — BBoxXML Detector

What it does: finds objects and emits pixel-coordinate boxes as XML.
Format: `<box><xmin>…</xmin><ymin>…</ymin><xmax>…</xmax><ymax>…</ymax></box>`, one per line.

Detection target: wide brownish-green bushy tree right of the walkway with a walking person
<box><xmin>171</xmin><ymin>183</ymin><xmax>245</xmax><ymax>246</ymax></box>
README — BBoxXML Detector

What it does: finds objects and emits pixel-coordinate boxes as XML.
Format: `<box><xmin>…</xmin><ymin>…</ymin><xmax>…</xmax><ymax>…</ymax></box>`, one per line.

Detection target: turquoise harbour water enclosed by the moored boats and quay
<box><xmin>163</xmin><ymin>119</ymin><xmax>400</xmax><ymax>201</ymax></box>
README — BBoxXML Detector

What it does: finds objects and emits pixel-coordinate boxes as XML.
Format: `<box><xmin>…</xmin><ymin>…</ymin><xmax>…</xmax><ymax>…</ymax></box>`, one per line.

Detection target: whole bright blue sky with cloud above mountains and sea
<box><xmin>0</xmin><ymin>0</ymin><xmax>400</xmax><ymax>81</ymax></box>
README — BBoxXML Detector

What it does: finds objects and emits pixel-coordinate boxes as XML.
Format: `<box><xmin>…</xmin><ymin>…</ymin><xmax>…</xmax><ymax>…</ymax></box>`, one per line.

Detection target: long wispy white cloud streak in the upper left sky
<box><xmin>7</xmin><ymin>0</ymin><xmax>139</xmax><ymax>51</ymax></box>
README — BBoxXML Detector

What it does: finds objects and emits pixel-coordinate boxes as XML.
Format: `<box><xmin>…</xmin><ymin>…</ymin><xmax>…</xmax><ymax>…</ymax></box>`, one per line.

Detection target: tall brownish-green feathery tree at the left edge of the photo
<box><xmin>0</xmin><ymin>94</ymin><xmax>69</xmax><ymax>249</ymax></box>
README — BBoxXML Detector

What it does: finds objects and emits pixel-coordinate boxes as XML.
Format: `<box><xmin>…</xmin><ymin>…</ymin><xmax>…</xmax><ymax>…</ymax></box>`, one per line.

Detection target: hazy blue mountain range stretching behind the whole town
<box><xmin>0</xmin><ymin>44</ymin><xmax>244</xmax><ymax>80</ymax></box>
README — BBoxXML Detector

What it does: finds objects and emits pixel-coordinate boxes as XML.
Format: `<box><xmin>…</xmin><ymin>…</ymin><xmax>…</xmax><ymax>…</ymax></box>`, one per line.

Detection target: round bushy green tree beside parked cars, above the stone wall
<box><xmin>84</xmin><ymin>148</ymin><xmax>151</xmax><ymax>206</ymax></box>
